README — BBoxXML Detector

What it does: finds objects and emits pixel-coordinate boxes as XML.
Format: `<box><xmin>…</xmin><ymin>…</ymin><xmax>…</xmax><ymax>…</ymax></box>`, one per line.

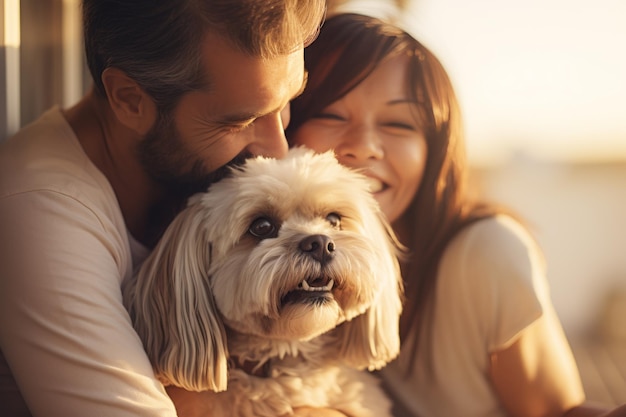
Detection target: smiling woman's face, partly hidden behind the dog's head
<box><xmin>291</xmin><ymin>55</ymin><xmax>428</xmax><ymax>222</ymax></box>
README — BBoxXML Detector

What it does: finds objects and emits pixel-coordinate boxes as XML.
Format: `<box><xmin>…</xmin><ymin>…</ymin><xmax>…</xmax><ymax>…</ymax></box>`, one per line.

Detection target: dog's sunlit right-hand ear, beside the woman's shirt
<box><xmin>335</xmin><ymin>211</ymin><xmax>404</xmax><ymax>370</ymax></box>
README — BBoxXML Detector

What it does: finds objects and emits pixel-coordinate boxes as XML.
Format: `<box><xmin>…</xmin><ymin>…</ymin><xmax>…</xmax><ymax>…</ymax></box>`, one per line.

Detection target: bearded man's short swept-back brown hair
<box><xmin>82</xmin><ymin>0</ymin><xmax>325</xmax><ymax>109</ymax></box>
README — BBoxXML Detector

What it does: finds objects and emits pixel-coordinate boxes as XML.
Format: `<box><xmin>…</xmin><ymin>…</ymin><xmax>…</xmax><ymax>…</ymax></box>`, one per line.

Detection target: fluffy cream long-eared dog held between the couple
<box><xmin>123</xmin><ymin>148</ymin><xmax>402</xmax><ymax>417</ymax></box>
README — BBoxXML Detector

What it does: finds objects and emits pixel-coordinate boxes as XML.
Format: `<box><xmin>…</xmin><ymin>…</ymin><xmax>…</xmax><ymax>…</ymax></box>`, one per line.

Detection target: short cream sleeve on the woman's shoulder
<box><xmin>448</xmin><ymin>216</ymin><xmax>550</xmax><ymax>352</ymax></box>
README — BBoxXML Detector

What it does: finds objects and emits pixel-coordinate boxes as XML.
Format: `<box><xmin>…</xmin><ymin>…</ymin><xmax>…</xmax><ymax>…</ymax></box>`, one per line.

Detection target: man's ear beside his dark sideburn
<box><xmin>102</xmin><ymin>67</ymin><xmax>157</xmax><ymax>136</ymax></box>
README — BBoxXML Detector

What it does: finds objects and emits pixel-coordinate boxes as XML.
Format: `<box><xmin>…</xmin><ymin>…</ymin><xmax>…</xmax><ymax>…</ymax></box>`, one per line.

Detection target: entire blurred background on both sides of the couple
<box><xmin>0</xmin><ymin>0</ymin><xmax>626</xmax><ymax>404</ymax></box>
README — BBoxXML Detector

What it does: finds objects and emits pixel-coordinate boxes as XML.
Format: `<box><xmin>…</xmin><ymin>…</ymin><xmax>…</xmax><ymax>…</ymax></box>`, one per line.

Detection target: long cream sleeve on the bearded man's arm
<box><xmin>0</xmin><ymin>190</ymin><xmax>176</xmax><ymax>417</ymax></box>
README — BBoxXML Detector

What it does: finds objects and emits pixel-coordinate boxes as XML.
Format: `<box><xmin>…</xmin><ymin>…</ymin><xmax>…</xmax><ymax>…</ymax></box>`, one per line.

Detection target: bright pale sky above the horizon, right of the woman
<box><xmin>338</xmin><ymin>0</ymin><xmax>626</xmax><ymax>163</ymax></box>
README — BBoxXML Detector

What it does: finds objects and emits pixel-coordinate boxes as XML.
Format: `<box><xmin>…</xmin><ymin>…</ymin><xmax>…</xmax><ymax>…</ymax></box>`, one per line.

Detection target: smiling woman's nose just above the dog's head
<box><xmin>335</xmin><ymin>124</ymin><xmax>385</xmax><ymax>161</ymax></box>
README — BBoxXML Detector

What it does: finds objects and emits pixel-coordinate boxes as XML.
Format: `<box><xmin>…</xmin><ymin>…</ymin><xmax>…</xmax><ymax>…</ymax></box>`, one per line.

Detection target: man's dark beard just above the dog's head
<box><xmin>138</xmin><ymin>111</ymin><xmax>251</xmax><ymax>199</ymax></box>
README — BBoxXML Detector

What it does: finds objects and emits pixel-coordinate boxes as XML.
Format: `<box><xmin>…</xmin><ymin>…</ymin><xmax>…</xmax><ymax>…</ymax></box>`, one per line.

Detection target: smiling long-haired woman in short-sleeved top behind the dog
<box><xmin>287</xmin><ymin>14</ymin><xmax>624</xmax><ymax>417</ymax></box>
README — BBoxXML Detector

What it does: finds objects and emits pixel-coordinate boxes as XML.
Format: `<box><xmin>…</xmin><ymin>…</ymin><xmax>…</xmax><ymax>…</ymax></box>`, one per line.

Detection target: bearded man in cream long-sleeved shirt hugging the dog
<box><xmin>0</xmin><ymin>0</ymin><xmax>324</xmax><ymax>417</ymax></box>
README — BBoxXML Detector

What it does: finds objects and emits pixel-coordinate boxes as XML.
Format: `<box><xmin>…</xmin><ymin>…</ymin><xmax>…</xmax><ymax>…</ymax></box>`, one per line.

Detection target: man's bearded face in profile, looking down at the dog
<box><xmin>139</xmin><ymin>35</ymin><xmax>305</xmax><ymax>194</ymax></box>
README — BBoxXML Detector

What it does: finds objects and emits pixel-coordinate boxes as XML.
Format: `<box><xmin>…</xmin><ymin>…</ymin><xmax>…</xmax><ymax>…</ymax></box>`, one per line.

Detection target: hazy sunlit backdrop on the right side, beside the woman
<box><xmin>401</xmin><ymin>0</ymin><xmax>626</xmax><ymax>342</ymax></box>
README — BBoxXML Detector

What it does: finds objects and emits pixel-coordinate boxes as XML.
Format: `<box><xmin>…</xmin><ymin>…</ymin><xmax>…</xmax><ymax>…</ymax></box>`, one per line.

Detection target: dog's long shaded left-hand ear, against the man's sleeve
<box><xmin>123</xmin><ymin>204</ymin><xmax>228</xmax><ymax>391</ymax></box>
